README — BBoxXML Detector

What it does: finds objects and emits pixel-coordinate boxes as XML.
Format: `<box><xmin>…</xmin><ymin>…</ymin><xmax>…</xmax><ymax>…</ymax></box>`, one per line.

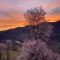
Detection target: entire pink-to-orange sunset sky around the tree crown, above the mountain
<box><xmin>0</xmin><ymin>0</ymin><xmax>60</xmax><ymax>31</ymax></box>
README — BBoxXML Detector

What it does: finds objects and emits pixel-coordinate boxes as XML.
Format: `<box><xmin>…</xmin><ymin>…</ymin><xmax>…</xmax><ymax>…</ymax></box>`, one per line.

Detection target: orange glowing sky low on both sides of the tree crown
<box><xmin>0</xmin><ymin>13</ymin><xmax>60</xmax><ymax>31</ymax></box>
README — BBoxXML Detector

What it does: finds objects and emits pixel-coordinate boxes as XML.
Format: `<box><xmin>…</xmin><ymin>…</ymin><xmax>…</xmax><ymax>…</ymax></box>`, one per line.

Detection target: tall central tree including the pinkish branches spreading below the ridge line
<box><xmin>24</xmin><ymin>7</ymin><xmax>52</xmax><ymax>41</ymax></box>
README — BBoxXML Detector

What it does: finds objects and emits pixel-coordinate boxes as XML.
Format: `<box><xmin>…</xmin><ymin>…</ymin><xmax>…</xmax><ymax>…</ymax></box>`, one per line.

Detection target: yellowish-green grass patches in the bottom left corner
<box><xmin>2</xmin><ymin>50</ymin><xmax>18</xmax><ymax>60</ymax></box>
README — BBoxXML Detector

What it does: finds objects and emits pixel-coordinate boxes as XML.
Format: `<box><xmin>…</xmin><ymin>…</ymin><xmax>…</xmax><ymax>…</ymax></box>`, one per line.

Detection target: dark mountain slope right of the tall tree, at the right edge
<box><xmin>51</xmin><ymin>21</ymin><xmax>60</xmax><ymax>42</ymax></box>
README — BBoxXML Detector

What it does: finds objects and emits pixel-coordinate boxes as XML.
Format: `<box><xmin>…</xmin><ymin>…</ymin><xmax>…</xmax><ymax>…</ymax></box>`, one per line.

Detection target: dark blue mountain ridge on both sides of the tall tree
<box><xmin>0</xmin><ymin>21</ymin><xmax>60</xmax><ymax>42</ymax></box>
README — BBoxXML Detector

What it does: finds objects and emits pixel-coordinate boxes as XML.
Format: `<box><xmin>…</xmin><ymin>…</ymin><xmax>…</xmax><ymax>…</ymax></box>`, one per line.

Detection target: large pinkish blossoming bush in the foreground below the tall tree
<box><xmin>20</xmin><ymin>40</ymin><xmax>60</xmax><ymax>60</ymax></box>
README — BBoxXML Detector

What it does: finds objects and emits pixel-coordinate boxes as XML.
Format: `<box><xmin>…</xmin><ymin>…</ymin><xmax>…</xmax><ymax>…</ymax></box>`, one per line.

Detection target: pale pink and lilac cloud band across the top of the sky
<box><xmin>0</xmin><ymin>0</ymin><xmax>60</xmax><ymax>11</ymax></box>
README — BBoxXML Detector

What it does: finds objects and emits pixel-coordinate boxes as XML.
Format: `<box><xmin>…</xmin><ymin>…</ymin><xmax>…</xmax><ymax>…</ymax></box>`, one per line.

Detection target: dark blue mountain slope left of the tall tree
<box><xmin>0</xmin><ymin>26</ymin><xmax>32</xmax><ymax>42</ymax></box>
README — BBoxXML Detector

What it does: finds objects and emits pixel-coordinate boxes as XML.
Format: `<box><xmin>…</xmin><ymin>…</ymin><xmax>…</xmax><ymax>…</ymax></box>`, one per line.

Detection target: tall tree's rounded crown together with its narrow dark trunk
<box><xmin>24</xmin><ymin>7</ymin><xmax>46</xmax><ymax>40</ymax></box>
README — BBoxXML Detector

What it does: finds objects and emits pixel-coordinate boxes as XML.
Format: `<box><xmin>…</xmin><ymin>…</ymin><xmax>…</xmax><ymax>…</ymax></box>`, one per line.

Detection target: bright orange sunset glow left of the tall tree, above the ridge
<box><xmin>0</xmin><ymin>13</ymin><xmax>27</xmax><ymax>31</ymax></box>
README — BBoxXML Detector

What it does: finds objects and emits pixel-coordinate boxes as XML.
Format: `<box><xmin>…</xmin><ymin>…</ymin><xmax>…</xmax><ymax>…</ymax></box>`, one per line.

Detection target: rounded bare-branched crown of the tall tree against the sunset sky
<box><xmin>24</xmin><ymin>7</ymin><xmax>46</xmax><ymax>26</ymax></box>
